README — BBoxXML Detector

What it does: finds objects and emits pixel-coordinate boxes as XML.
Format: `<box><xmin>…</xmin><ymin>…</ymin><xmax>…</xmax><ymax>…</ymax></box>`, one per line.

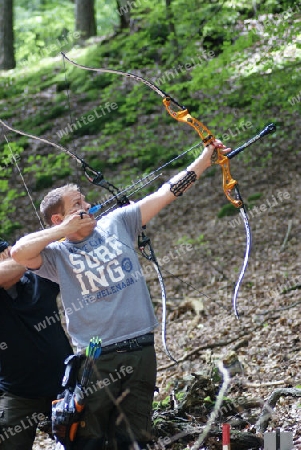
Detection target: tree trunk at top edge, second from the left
<box><xmin>75</xmin><ymin>0</ymin><xmax>97</xmax><ymax>39</ymax></box>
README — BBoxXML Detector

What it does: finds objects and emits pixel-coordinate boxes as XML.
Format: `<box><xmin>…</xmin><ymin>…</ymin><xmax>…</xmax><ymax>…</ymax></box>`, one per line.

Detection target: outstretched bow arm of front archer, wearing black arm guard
<box><xmin>138</xmin><ymin>140</ymin><xmax>230</xmax><ymax>225</ymax></box>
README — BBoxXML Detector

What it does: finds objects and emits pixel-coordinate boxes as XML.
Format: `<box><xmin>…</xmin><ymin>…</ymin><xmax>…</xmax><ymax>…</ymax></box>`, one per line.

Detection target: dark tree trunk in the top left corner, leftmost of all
<box><xmin>0</xmin><ymin>0</ymin><xmax>16</xmax><ymax>70</ymax></box>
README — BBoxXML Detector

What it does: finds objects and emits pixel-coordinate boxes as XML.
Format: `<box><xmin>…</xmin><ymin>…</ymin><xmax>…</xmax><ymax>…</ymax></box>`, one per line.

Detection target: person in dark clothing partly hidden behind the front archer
<box><xmin>0</xmin><ymin>240</ymin><xmax>72</xmax><ymax>450</ymax></box>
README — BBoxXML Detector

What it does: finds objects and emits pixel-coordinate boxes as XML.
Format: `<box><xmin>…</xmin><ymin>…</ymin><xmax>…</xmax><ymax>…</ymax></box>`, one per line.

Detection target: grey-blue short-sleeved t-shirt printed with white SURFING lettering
<box><xmin>36</xmin><ymin>204</ymin><xmax>158</xmax><ymax>350</ymax></box>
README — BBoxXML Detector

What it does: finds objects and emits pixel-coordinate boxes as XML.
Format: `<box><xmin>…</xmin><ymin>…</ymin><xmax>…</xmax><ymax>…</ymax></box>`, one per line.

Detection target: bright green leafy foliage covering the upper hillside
<box><xmin>0</xmin><ymin>0</ymin><xmax>300</xmax><ymax>239</ymax></box>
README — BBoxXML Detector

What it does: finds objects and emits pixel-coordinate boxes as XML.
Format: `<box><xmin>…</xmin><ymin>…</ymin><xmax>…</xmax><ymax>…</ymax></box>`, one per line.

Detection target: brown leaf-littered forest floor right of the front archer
<box><xmin>27</xmin><ymin>128</ymin><xmax>301</xmax><ymax>450</ymax></box>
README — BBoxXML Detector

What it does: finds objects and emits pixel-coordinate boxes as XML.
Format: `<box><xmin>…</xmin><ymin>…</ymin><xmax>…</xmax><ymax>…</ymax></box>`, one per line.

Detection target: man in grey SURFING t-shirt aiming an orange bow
<box><xmin>12</xmin><ymin>141</ymin><xmax>230</xmax><ymax>450</ymax></box>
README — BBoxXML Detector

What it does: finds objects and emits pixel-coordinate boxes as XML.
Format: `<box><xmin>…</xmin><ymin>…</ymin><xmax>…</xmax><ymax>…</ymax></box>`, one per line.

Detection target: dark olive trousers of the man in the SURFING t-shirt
<box><xmin>75</xmin><ymin>345</ymin><xmax>156</xmax><ymax>450</ymax></box>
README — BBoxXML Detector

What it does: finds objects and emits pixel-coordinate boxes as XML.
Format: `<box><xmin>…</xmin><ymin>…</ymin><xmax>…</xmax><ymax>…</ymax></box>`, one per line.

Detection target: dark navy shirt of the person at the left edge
<box><xmin>0</xmin><ymin>272</ymin><xmax>72</xmax><ymax>398</ymax></box>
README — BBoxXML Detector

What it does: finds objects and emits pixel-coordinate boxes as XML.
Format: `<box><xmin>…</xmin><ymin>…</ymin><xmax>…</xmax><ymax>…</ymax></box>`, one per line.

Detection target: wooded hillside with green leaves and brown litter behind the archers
<box><xmin>0</xmin><ymin>0</ymin><xmax>301</xmax><ymax>449</ymax></box>
